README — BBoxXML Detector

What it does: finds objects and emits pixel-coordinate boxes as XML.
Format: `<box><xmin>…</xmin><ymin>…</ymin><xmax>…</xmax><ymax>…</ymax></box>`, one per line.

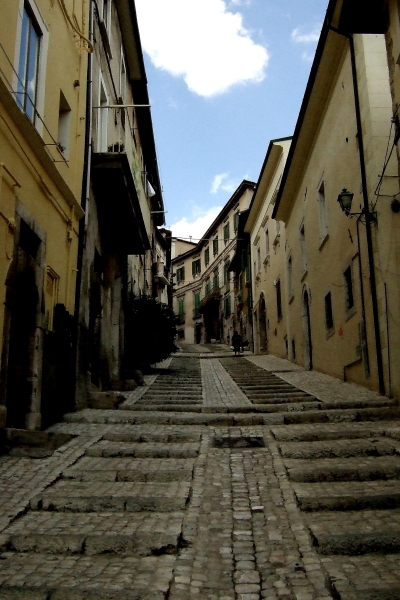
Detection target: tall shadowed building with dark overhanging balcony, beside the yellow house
<box><xmin>76</xmin><ymin>0</ymin><xmax>164</xmax><ymax>408</ymax></box>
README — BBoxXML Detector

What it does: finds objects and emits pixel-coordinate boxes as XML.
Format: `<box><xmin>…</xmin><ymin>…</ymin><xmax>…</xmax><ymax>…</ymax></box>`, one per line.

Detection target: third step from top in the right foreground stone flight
<box><xmin>285</xmin><ymin>456</ymin><xmax>400</xmax><ymax>483</ymax></box>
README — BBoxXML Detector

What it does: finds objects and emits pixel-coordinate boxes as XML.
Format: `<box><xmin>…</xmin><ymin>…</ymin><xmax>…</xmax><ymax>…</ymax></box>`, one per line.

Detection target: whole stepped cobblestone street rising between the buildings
<box><xmin>0</xmin><ymin>354</ymin><xmax>400</xmax><ymax>600</ymax></box>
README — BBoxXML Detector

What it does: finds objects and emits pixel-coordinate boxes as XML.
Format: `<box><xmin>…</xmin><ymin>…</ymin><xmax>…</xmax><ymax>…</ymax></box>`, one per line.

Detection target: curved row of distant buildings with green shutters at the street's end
<box><xmin>172</xmin><ymin>180</ymin><xmax>255</xmax><ymax>344</ymax></box>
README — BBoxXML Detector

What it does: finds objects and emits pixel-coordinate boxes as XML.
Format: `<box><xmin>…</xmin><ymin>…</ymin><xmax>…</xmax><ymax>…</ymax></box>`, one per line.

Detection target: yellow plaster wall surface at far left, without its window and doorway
<box><xmin>0</xmin><ymin>0</ymin><xmax>88</xmax><ymax>429</ymax></box>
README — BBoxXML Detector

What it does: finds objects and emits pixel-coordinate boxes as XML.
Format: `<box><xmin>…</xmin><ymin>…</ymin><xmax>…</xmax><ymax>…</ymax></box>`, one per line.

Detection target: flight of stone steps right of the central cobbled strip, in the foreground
<box><xmin>272</xmin><ymin>422</ymin><xmax>400</xmax><ymax>600</ymax></box>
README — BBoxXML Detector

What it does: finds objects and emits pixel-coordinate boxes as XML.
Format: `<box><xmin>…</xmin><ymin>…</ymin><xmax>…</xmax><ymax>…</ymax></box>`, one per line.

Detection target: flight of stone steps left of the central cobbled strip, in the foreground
<box><xmin>0</xmin><ymin>424</ymin><xmax>200</xmax><ymax>600</ymax></box>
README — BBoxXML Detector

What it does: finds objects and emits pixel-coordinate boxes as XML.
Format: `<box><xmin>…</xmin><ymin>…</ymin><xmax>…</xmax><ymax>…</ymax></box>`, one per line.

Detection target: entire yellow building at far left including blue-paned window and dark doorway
<box><xmin>0</xmin><ymin>0</ymin><xmax>92</xmax><ymax>430</ymax></box>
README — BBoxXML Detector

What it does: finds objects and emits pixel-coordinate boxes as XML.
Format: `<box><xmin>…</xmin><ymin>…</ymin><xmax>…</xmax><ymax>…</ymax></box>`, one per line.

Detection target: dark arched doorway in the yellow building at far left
<box><xmin>6</xmin><ymin>268</ymin><xmax>38</xmax><ymax>429</ymax></box>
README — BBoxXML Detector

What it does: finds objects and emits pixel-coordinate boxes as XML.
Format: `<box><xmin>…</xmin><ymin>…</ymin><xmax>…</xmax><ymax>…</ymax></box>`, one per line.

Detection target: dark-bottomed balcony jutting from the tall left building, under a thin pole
<box><xmin>92</xmin><ymin>107</ymin><xmax>151</xmax><ymax>254</ymax></box>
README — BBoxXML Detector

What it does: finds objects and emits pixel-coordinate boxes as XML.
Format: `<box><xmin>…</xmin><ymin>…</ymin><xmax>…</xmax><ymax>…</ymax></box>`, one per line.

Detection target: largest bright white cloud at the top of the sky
<box><xmin>136</xmin><ymin>0</ymin><xmax>269</xmax><ymax>97</ymax></box>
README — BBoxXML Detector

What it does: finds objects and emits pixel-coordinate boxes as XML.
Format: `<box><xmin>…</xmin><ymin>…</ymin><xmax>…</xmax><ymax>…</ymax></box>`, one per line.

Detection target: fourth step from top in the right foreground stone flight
<box><xmin>293</xmin><ymin>480</ymin><xmax>400</xmax><ymax>511</ymax></box>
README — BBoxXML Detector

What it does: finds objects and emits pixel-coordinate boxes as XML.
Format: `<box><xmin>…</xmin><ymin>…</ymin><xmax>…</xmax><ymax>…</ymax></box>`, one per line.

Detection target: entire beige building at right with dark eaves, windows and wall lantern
<box><xmin>272</xmin><ymin>1</ymin><xmax>400</xmax><ymax>395</ymax></box>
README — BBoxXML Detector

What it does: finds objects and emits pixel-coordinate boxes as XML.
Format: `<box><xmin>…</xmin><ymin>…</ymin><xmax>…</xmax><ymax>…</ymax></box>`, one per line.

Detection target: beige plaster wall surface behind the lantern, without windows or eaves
<box><xmin>277</xmin><ymin>35</ymin><xmax>399</xmax><ymax>393</ymax></box>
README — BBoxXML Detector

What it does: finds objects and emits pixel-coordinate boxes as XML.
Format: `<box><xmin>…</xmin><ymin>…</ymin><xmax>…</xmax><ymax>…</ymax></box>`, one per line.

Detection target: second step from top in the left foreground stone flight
<box><xmin>86</xmin><ymin>440</ymin><xmax>199</xmax><ymax>458</ymax></box>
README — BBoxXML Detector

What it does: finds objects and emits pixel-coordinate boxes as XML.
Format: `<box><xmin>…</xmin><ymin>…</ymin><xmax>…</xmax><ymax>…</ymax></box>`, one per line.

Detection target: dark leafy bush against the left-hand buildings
<box><xmin>125</xmin><ymin>295</ymin><xmax>178</xmax><ymax>375</ymax></box>
